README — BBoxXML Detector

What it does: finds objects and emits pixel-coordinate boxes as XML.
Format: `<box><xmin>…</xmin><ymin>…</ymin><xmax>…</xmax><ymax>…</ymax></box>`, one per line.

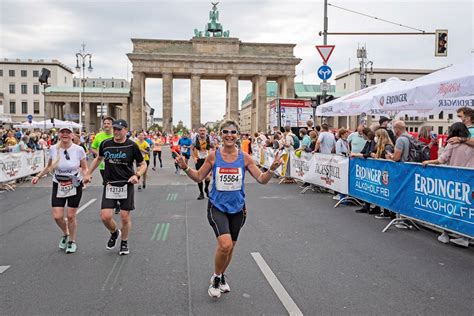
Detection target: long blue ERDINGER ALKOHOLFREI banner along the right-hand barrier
<box><xmin>349</xmin><ymin>159</ymin><xmax>474</xmax><ymax>238</ymax></box>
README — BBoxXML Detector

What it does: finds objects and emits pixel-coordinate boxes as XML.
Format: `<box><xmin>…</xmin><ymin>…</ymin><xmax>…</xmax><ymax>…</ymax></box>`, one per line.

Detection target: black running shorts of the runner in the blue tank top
<box><xmin>207</xmin><ymin>202</ymin><xmax>247</xmax><ymax>241</ymax></box>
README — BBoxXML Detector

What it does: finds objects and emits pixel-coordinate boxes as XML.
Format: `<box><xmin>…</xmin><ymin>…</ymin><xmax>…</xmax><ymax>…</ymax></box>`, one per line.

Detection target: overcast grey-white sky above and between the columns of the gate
<box><xmin>0</xmin><ymin>0</ymin><xmax>474</xmax><ymax>125</ymax></box>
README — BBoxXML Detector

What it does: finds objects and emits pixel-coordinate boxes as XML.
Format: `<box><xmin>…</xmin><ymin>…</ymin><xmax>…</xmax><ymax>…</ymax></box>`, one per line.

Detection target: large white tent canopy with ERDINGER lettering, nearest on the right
<box><xmin>373</xmin><ymin>54</ymin><xmax>474</xmax><ymax>112</ymax></box>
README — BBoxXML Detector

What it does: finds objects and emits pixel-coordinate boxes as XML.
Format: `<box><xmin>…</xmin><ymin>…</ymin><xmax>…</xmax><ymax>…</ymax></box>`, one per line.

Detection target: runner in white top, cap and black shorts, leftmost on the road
<box><xmin>31</xmin><ymin>128</ymin><xmax>88</xmax><ymax>253</ymax></box>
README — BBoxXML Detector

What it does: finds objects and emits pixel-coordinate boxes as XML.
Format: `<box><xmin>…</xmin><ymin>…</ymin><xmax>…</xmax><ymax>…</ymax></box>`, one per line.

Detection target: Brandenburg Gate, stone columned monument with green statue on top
<box><xmin>127</xmin><ymin>5</ymin><xmax>301</xmax><ymax>132</ymax></box>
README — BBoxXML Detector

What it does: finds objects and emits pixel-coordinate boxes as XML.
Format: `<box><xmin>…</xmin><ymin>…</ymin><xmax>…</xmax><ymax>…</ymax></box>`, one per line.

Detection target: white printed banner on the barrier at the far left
<box><xmin>0</xmin><ymin>151</ymin><xmax>44</xmax><ymax>182</ymax></box>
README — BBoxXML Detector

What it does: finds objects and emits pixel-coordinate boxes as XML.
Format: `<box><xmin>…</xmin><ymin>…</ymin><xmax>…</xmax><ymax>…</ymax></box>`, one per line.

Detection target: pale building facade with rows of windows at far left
<box><xmin>0</xmin><ymin>58</ymin><xmax>73</xmax><ymax>123</ymax></box>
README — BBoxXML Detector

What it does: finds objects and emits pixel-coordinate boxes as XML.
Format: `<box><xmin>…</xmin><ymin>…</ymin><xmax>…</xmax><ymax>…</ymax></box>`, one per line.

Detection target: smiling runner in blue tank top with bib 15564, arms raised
<box><xmin>175</xmin><ymin>120</ymin><xmax>283</xmax><ymax>298</ymax></box>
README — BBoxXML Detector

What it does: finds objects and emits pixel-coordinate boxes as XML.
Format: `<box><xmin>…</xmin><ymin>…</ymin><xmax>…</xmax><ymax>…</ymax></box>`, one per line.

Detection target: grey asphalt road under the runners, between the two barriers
<box><xmin>0</xmin><ymin>148</ymin><xmax>474</xmax><ymax>315</ymax></box>
